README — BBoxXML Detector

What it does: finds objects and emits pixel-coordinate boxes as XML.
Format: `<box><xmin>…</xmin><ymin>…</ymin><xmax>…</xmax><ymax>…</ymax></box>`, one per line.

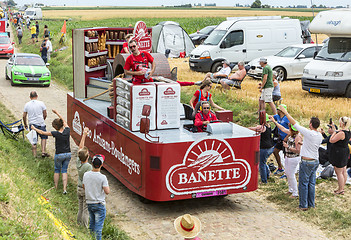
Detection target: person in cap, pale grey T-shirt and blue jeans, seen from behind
<box><xmin>83</xmin><ymin>155</ymin><xmax>110</xmax><ymax>240</ymax></box>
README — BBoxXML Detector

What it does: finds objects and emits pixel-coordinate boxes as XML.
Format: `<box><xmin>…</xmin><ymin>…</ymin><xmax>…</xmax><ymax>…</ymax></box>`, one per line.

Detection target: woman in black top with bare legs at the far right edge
<box><xmin>329</xmin><ymin>117</ymin><xmax>351</xmax><ymax>194</ymax></box>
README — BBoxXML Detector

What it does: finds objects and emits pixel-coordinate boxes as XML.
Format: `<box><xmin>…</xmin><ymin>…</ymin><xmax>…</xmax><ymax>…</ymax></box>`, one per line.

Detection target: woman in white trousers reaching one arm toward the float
<box><xmin>270</xmin><ymin>116</ymin><xmax>302</xmax><ymax>198</ymax></box>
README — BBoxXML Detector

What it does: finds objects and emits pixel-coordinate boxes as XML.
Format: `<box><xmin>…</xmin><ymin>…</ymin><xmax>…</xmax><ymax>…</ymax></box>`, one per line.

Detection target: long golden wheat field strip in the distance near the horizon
<box><xmin>43</xmin><ymin>8</ymin><xmax>318</xmax><ymax>20</ymax></box>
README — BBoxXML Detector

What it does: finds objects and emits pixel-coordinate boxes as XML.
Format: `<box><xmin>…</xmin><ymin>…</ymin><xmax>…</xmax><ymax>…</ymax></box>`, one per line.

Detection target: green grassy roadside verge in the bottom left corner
<box><xmin>0</xmin><ymin>104</ymin><xmax>129</xmax><ymax>240</ymax></box>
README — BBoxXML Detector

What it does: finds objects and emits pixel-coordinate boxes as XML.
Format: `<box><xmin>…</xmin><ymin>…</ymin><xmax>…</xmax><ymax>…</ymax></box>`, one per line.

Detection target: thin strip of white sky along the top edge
<box><xmin>15</xmin><ymin>0</ymin><xmax>351</xmax><ymax>7</ymax></box>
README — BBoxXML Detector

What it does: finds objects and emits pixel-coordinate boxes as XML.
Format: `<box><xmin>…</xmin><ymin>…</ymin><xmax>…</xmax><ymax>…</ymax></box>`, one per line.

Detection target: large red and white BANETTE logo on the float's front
<box><xmin>166</xmin><ymin>138</ymin><xmax>251</xmax><ymax>195</ymax></box>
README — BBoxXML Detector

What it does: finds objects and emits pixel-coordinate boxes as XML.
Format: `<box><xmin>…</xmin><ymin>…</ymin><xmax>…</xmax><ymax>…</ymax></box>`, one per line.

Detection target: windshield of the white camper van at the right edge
<box><xmin>315</xmin><ymin>38</ymin><xmax>351</xmax><ymax>62</ymax></box>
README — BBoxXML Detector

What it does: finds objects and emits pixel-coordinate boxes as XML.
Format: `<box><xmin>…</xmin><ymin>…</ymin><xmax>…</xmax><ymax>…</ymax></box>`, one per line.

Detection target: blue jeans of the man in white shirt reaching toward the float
<box><xmin>299</xmin><ymin>159</ymin><xmax>319</xmax><ymax>208</ymax></box>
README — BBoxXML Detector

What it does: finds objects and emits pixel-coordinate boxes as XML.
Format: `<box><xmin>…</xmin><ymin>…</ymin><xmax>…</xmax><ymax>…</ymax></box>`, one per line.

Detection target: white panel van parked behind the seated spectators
<box><xmin>189</xmin><ymin>16</ymin><xmax>302</xmax><ymax>72</ymax></box>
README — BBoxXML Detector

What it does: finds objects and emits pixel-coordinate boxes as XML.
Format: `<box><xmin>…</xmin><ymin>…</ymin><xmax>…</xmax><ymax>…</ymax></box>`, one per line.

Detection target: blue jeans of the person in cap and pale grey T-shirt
<box><xmin>88</xmin><ymin>204</ymin><xmax>106</xmax><ymax>240</ymax></box>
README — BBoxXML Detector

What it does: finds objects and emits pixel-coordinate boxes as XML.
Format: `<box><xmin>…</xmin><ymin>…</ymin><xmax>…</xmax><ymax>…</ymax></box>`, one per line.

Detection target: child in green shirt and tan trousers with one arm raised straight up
<box><xmin>77</xmin><ymin>127</ymin><xmax>93</xmax><ymax>228</ymax></box>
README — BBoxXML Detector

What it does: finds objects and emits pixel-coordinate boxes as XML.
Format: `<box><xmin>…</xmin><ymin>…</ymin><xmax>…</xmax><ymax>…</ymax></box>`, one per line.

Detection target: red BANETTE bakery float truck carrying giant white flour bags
<box><xmin>67</xmin><ymin>23</ymin><xmax>259</xmax><ymax>201</ymax></box>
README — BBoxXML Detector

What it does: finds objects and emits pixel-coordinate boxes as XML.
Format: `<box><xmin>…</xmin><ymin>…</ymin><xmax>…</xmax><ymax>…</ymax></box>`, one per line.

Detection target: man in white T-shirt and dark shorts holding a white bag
<box><xmin>23</xmin><ymin>91</ymin><xmax>49</xmax><ymax>157</ymax></box>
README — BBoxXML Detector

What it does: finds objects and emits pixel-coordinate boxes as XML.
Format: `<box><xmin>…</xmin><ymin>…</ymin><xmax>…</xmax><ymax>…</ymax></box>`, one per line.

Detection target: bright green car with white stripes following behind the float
<box><xmin>5</xmin><ymin>53</ymin><xmax>51</xmax><ymax>87</ymax></box>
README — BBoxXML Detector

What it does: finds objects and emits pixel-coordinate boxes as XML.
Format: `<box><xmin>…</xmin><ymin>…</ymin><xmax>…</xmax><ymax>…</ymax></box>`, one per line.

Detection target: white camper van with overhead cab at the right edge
<box><xmin>302</xmin><ymin>9</ymin><xmax>351</xmax><ymax>98</ymax></box>
